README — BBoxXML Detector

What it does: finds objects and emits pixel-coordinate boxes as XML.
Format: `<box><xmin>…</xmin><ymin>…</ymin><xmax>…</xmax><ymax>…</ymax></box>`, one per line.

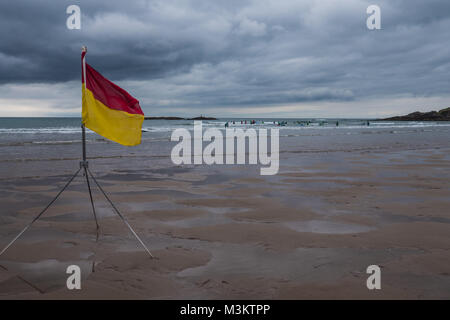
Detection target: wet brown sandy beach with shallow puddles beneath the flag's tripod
<box><xmin>0</xmin><ymin>121</ymin><xmax>450</xmax><ymax>299</ymax></box>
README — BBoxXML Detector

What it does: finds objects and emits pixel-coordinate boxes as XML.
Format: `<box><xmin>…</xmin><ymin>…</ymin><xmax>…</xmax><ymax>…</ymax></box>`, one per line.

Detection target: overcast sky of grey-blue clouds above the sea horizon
<box><xmin>0</xmin><ymin>0</ymin><xmax>450</xmax><ymax>118</ymax></box>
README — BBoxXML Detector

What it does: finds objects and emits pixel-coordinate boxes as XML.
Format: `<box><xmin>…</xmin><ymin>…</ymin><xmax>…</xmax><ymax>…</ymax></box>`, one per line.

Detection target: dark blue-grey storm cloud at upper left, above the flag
<box><xmin>0</xmin><ymin>0</ymin><xmax>216</xmax><ymax>83</ymax></box>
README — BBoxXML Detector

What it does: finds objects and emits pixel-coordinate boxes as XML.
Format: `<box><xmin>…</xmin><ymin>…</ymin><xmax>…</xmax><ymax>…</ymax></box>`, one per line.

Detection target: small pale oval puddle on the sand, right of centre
<box><xmin>283</xmin><ymin>220</ymin><xmax>375</xmax><ymax>234</ymax></box>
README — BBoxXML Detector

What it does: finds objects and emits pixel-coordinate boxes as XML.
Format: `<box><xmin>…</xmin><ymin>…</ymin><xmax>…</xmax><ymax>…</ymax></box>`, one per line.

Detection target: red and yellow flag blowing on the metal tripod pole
<box><xmin>81</xmin><ymin>51</ymin><xmax>144</xmax><ymax>146</ymax></box>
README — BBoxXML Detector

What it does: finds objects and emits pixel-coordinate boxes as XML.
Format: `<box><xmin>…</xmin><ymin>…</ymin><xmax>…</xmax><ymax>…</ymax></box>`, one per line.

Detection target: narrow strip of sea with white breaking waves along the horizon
<box><xmin>0</xmin><ymin>117</ymin><xmax>450</xmax><ymax>145</ymax></box>
